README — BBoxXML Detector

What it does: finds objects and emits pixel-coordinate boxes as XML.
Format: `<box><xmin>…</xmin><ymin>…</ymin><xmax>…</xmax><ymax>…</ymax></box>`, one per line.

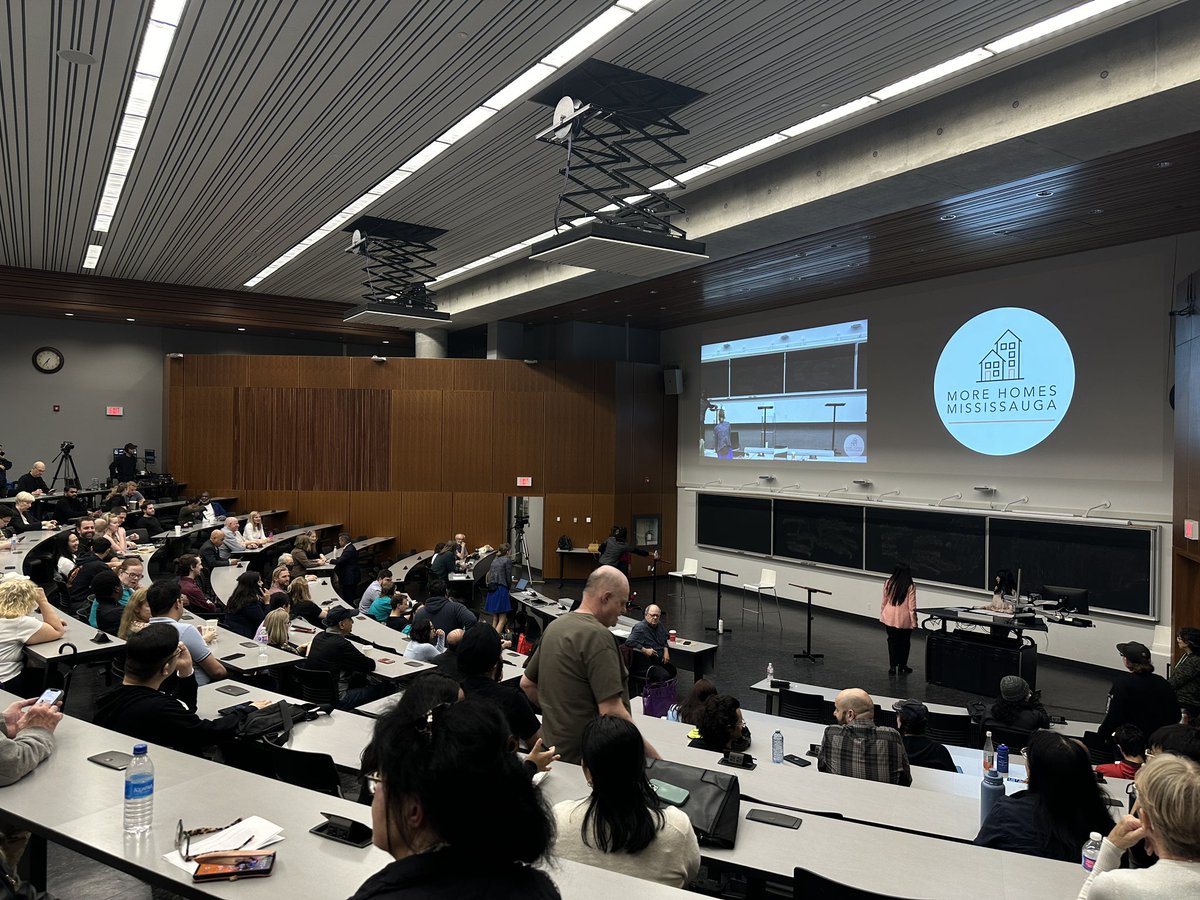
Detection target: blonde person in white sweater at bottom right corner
<box><xmin>1079</xmin><ymin>754</ymin><xmax>1200</xmax><ymax>900</ymax></box>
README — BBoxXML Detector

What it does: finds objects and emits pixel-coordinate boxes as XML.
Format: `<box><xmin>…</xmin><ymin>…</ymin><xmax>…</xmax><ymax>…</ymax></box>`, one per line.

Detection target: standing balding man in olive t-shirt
<box><xmin>521</xmin><ymin>565</ymin><xmax>659</xmax><ymax>763</ymax></box>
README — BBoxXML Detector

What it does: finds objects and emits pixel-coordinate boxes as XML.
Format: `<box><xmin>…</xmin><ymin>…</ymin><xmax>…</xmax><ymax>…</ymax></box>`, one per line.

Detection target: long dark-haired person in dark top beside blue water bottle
<box><xmin>974</xmin><ymin>730</ymin><xmax>1112</xmax><ymax>862</ymax></box>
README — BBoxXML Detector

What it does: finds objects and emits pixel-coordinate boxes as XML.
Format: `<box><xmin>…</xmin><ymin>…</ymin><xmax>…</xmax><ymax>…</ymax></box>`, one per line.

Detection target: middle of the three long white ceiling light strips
<box><xmin>244</xmin><ymin>0</ymin><xmax>653</xmax><ymax>288</ymax></box>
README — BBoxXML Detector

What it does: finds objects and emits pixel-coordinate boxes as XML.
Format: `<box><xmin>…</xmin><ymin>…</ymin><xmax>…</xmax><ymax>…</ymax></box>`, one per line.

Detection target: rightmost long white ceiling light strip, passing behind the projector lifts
<box><xmin>432</xmin><ymin>0</ymin><xmax>1134</xmax><ymax>284</ymax></box>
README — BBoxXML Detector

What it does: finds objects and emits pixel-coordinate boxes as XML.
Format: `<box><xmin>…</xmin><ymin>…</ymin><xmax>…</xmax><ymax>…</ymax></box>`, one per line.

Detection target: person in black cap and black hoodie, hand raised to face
<box><xmin>95</xmin><ymin>624</ymin><xmax>264</xmax><ymax>754</ymax></box>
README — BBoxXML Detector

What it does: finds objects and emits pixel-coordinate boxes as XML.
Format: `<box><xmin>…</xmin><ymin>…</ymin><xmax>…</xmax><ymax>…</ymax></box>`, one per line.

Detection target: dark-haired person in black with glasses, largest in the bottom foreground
<box><xmin>347</xmin><ymin>705</ymin><xmax>559</xmax><ymax>900</ymax></box>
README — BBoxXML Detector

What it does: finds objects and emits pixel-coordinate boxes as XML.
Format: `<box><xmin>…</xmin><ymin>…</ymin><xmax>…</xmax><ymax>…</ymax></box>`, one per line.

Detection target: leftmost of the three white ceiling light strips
<box><xmin>84</xmin><ymin>0</ymin><xmax>187</xmax><ymax>243</ymax></box>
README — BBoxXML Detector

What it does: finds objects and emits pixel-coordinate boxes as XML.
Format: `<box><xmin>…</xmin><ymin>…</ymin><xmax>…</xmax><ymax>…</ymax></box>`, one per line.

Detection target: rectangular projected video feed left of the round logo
<box><xmin>700</xmin><ymin>319</ymin><xmax>868</xmax><ymax>462</ymax></box>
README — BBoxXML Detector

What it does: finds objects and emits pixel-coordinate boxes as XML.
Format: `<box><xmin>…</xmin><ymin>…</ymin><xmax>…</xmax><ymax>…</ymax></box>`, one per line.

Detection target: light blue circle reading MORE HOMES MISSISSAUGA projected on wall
<box><xmin>934</xmin><ymin>306</ymin><xmax>1075</xmax><ymax>456</ymax></box>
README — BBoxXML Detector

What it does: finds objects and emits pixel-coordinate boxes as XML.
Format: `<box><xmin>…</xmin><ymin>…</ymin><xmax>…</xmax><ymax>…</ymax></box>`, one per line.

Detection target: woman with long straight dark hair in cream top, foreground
<box><xmin>554</xmin><ymin>715</ymin><xmax>700</xmax><ymax>888</ymax></box>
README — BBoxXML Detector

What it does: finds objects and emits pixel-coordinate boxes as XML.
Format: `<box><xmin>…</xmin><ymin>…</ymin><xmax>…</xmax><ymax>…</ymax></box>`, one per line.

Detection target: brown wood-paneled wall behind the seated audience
<box><xmin>166</xmin><ymin>354</ymin><xmax>677</xmax><ymax>577</ymax></box>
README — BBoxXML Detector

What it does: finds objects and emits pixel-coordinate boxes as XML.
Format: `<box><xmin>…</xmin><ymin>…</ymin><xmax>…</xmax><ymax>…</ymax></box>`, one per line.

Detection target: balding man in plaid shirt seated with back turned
<box><xmin>817</xmin><ymin>688</ymin><xmax>912</xmax><ymax>787</ymax></box>
